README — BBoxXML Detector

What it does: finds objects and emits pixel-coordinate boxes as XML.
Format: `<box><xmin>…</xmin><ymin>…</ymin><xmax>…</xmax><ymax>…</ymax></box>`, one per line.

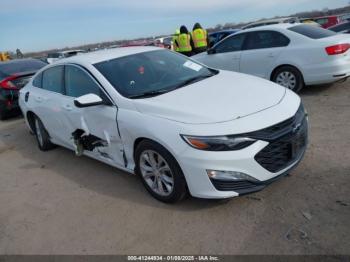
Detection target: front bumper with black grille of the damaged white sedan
<box><xmin>179</xmin><ymin>104</ymin><xmax>308</xmax><ymax>198</ymax></box>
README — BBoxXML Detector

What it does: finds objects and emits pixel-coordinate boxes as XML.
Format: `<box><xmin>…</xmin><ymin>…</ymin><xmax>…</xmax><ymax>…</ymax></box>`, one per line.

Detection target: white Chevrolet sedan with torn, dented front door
<box><xmin>19</xmin><ymin>47</ymin><xmax>308</xmax><ymax>202</ymax></box>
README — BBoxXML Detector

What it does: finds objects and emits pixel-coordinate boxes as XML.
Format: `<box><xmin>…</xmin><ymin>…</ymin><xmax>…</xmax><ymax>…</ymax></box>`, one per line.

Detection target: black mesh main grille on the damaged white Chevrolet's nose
<box><xmin>255</xmin><ymin>106</ymin><xmax>307</xmax><ymax>173</ymax></box>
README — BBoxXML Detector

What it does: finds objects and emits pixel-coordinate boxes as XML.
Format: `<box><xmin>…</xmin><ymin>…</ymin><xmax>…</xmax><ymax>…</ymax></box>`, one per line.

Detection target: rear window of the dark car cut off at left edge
<box><xmin>0</xmin><ymin>59</ymin><xmax>47</xmax><ymax>78</ymax></box>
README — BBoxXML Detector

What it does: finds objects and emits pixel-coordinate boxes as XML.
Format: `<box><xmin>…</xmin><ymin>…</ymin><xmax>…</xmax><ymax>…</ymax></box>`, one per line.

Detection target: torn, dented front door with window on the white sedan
<box><xmin>62</xmin><ymin>65</ymin><xmax>124</xmax><ymax>166</ymax></box>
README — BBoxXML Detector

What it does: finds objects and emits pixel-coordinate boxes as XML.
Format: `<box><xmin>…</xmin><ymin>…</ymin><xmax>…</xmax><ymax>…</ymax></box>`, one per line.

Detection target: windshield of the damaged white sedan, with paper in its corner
<box><xmin>94</xmin><ymin>50</ymin><xmax>218</xmax><ymax>98</ymax></box>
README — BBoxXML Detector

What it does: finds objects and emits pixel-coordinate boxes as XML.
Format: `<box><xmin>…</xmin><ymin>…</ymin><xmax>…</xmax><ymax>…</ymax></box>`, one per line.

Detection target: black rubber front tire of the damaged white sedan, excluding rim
<box><xmin>135</xmin><ymin>140</ymin><xmax>188</xmax><ymax>203</ymax></box>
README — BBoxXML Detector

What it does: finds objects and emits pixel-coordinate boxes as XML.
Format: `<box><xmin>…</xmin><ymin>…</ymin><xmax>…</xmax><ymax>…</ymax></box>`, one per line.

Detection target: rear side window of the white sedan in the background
<box><xmin>245</xmin><ymin>31</ymin><xmax>290</xmax><ymax>50</ymax></box>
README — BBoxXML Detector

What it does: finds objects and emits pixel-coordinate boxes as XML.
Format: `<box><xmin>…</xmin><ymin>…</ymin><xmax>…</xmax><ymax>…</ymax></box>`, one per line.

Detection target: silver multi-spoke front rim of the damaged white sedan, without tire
<box><xmin>140</xmin><ymin>150</ymin><xmax>174</xmax><ymax>196</ymax></box>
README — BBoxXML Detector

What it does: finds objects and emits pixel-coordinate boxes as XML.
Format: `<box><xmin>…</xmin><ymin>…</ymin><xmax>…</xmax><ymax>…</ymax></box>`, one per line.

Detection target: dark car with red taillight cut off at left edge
<box><xmin>0</xmin><ymin>59</ymin><xmax>47</xmax><ymax>120</ymax></box>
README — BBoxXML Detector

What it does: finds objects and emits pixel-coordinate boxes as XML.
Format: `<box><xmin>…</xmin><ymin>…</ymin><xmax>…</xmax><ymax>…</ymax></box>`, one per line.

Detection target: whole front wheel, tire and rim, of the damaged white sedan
<box><xmin>135</xmin><ymin>140</ymin><xmax>187</xmax><ymax>203</ymax></box>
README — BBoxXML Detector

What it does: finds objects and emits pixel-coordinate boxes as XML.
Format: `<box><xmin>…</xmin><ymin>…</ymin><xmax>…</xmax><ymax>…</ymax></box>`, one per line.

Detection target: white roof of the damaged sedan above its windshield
<box><xmin>55</xmin><ymin>46</ymin><xmax>164</xmax><ymax>64</ymax></box>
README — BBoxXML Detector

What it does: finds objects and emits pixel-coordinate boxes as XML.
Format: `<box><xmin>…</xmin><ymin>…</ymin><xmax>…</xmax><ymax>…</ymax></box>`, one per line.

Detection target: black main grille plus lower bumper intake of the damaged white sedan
<box><xmin>206</xmin><ymin>105</ymin><xmax>308</xmax><ymax>195</ymax></box>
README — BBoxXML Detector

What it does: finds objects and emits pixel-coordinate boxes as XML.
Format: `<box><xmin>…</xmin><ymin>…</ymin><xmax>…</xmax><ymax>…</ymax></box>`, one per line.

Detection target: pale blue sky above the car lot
<box><xmin>0</xmin><ymin>0</ymin><xmax>349</xmax><ymax>52</ymax></box>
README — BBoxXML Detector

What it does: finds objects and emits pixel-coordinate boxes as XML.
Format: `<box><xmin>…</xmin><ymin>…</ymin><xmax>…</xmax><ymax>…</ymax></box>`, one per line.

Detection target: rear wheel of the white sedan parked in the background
<box><xmin>272</xmin><ymin>66</ymin><xmax>305</xmax><ymax>93</ymax></box>
